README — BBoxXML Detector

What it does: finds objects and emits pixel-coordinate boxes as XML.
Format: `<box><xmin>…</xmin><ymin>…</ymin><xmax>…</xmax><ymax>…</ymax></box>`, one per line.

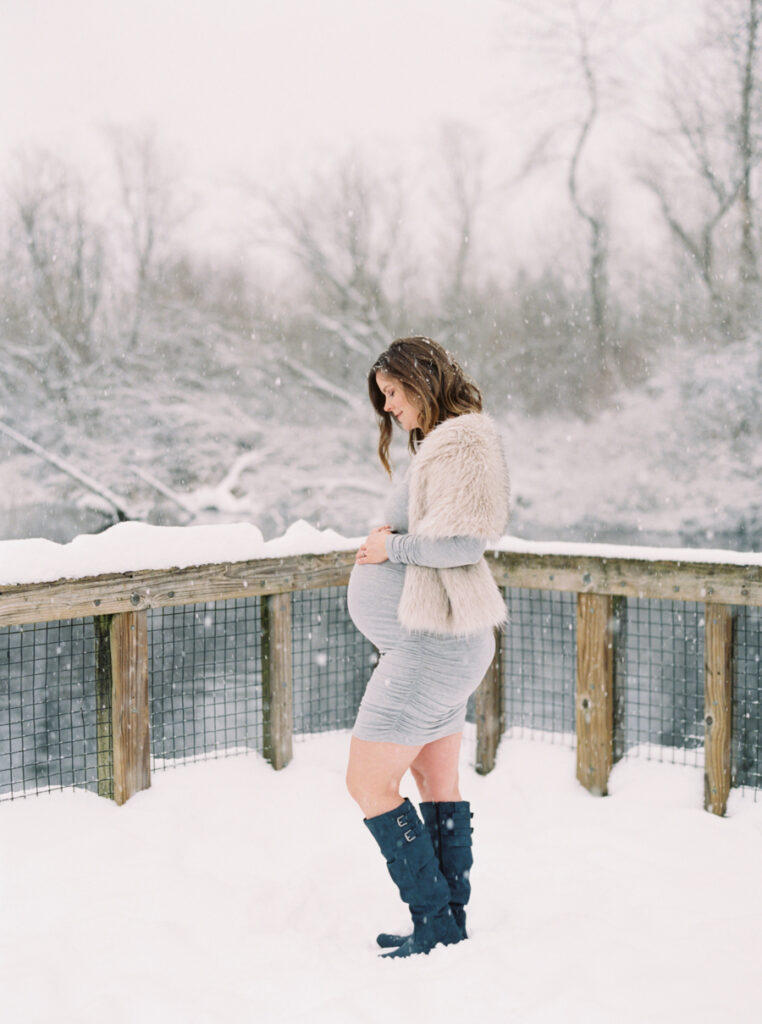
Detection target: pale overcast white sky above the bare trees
<box><xmin>0</xmin><ymin>0</ymin><xmax>699</xmax><ymax>274</ymax></box>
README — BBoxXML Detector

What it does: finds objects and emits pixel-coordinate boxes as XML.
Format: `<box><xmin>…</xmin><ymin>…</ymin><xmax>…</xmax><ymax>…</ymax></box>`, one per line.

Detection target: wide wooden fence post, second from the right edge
<box><xmin>577</xmin><ymin>594</ymin><xmax>613</xmax><ymax>797</ymax></box>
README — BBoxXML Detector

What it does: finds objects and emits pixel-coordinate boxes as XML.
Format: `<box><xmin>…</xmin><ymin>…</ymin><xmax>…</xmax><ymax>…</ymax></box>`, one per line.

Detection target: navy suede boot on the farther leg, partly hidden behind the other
<box><xmin>376</xmin><ymin>800</ymin><xmax>473</xmax><ymax>949</ymax></box>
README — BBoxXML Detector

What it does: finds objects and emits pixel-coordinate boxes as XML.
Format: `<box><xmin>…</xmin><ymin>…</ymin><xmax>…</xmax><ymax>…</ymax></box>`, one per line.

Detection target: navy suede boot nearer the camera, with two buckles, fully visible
<box><xmin>365</xmin><ymin>798</ymin><xmax>462</xmax><ymax>956</ymax></box>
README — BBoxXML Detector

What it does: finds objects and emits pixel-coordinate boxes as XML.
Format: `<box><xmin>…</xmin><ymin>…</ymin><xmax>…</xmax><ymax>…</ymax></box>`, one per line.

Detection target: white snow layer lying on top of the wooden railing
<box><xmin>0</xmin><ymin>519</ymin><xmax>762</xmax><ymax>586</ymax></box>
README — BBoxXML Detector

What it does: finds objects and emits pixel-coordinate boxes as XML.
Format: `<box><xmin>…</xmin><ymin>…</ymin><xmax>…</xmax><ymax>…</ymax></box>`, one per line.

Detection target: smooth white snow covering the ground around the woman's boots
<box><xmin>0</xmin><ymin>733</ymin><xmax>762</xmax><ymax>1024</ymax></box>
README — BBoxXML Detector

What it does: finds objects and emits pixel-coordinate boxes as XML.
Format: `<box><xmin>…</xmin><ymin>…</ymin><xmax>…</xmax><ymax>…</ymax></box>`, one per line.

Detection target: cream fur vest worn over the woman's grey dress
<box><xmin>397</xmin><ymin>413</ymin><xmax>510</xmax><ymax>635</ymax></box>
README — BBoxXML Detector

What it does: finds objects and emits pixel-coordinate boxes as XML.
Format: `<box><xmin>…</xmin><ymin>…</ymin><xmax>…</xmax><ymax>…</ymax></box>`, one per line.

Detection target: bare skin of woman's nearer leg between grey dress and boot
<box><xmin>346</xmin><ymin>736</ymin><xmax>422</xmax><ymax>818</ymax></box>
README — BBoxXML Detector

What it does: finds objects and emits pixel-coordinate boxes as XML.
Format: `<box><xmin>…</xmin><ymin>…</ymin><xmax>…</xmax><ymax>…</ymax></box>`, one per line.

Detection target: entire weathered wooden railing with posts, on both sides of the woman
<box><xmin>0</xmin><ymin>551</ymin><xmax>762</xmax><ymax>814</ymax></box>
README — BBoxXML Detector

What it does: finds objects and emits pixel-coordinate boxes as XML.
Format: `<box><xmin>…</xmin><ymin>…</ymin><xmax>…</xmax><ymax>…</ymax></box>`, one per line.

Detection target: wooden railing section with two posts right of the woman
<box><xmin>492</xmin><ymin>549</ymin><xmax>762</xmax><ymax>815</ymax></box>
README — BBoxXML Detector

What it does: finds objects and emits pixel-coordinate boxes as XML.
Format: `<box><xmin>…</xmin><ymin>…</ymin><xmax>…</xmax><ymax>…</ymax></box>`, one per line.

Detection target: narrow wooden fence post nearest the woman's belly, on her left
<box><xmin>261</xmin><ymin>594</ymin><xmax>294</xmax><ymax>770</ymax></box>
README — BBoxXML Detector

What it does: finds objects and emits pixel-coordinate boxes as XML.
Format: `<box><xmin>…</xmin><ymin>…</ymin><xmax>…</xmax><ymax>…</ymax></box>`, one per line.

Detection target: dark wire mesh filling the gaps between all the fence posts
<box><xmin>0</xmin><ymin>587</ymin><xmax>762</xmax><ymax>800</ymax></box>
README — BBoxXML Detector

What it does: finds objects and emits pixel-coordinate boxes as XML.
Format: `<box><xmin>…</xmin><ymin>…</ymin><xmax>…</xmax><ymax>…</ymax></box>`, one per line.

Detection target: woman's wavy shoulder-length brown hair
<box><xmin>368</xmin><ymin>337</ymin><xmax>481</xmax><ymax>475</ymax></box>
